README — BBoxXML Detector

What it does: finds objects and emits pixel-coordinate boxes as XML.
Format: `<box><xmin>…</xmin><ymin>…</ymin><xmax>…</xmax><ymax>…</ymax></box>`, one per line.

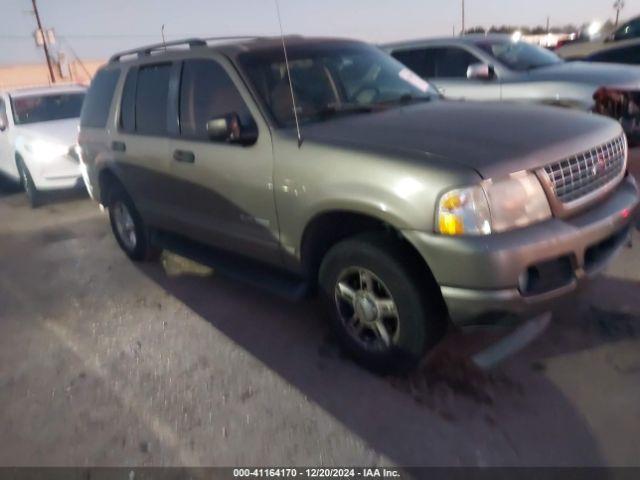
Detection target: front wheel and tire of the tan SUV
<box><xmin>319</xmin><ymin>235</ymin><xmax>447</xmax><ymax>373</ymax></box>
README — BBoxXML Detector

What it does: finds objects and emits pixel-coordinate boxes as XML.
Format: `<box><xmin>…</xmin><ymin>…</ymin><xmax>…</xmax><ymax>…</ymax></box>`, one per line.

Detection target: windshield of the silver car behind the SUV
<box><xmin>477</xmin><ymin>40</ymin><xmax>563</xmax><ymax>72</ymax></box>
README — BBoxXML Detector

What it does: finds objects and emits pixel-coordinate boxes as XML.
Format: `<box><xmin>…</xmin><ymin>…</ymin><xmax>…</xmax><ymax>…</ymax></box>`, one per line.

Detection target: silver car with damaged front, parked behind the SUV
<box><xmin>384</xmin><ymin>35</ymin><xmax>640</xmax><ymax>143</ymax></box>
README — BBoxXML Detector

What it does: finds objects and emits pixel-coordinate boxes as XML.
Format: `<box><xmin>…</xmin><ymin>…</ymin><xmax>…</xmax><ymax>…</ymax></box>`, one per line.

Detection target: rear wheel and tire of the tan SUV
<box><xmin>108</xmin><ymin>184</ymin><xmax>161</xmax><ymax>262</ymax></box>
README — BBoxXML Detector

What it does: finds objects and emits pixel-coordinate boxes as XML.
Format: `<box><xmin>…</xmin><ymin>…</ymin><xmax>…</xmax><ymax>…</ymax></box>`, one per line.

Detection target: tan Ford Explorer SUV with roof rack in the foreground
<box><xmin>79</xmin><ymin>37</ymin><xmax>638</xmax><ymax>370</ymax></box>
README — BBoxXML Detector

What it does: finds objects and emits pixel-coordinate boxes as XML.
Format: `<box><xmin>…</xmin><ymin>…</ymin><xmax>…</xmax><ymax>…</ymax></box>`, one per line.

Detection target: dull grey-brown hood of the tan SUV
<box><xmin>302</xmin><ymin>100</ymin><xmax>622</xmax><ymax>178</ymax></box>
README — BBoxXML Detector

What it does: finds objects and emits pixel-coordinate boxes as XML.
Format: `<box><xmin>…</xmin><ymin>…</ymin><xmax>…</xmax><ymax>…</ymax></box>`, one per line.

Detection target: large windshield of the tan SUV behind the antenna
<box><xmin>239</xmin><ymin>43</ymin><xmax>438</xmax><ymax>126</ymax></box>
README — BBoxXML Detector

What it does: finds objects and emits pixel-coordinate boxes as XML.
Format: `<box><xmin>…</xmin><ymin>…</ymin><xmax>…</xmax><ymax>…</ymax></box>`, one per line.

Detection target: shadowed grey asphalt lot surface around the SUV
<box><xmin>0</xmin><ymin>163</ymin><xmax>640</xmax><ymax>466</ymax></box>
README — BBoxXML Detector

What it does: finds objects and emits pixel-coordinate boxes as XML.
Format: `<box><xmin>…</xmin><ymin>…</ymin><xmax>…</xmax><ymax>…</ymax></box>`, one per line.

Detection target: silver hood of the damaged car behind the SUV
<box><xmin>527</xmin><ymin>62</ymin><xmax>640</xmax><ymax>90</ymax></box>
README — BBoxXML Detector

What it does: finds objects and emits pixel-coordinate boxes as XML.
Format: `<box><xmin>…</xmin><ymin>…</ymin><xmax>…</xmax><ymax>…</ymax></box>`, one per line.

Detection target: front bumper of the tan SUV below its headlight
<box><xmin>403</xmin><ymin>176</ymin><xmax>639</xmax><ymax>325</ymax></box>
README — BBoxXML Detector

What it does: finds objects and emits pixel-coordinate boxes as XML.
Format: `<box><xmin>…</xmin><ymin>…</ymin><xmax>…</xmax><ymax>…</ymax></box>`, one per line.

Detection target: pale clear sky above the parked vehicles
<box><xmin>0</xmin><ymin>0</ymin><xmax>640</xmax><ymax>64</ymax></box>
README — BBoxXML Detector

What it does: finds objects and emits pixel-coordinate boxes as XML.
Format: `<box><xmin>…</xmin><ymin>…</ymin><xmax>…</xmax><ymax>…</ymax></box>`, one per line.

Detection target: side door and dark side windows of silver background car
<box><xmin>393</xmin><ymin>46</ymin><xmax>500</xmax><ymax>100</ymax></box>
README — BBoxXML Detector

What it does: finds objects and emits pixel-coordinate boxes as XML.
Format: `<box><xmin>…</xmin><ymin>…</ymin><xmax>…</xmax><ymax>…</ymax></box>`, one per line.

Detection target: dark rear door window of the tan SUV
<box><xmin>135</xmin><ymin>64</ymin><xmax>171</xmax><ymax>135</ymax></box>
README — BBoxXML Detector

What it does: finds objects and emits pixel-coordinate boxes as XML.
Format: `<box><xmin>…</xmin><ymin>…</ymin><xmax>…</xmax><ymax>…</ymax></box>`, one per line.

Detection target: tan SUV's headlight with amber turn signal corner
<box><xmin>438</xmin><ymin>172</ymin><xmax>551</xmax><ymax>235</ymax></box>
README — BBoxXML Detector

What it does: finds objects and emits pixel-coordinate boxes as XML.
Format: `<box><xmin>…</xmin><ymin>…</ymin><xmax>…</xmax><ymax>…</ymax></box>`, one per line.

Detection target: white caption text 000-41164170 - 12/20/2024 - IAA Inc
<box><xmin>233</xmin><ymin>468</ymin><xmax>402</xmax><ymax>478</ymax></box>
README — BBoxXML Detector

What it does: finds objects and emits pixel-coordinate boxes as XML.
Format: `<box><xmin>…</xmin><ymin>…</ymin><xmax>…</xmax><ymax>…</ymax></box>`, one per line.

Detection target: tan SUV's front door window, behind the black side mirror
<box><xmin>180</xmin><ymin>60</ymin><xmax>256</xmax><ymax>140</ymax></box>
